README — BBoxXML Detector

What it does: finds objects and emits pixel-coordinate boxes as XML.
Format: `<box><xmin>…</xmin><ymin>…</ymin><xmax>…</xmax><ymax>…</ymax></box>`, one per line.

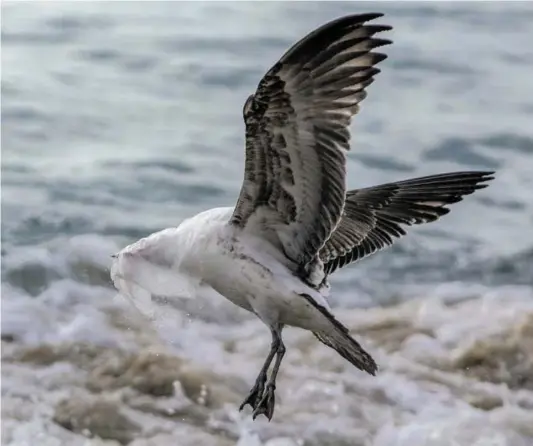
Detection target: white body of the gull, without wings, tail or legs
<box><xmin>110</xmin><ymin>208</ymin><xmax>328</xmax><ymax>329</ymax></box>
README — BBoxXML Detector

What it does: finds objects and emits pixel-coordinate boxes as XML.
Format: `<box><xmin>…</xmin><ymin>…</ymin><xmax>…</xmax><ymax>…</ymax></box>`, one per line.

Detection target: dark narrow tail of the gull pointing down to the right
<box><xmin>302</xmin><ymin>294</ymin><xmax>378</xmax><ymax>375</ymax></box>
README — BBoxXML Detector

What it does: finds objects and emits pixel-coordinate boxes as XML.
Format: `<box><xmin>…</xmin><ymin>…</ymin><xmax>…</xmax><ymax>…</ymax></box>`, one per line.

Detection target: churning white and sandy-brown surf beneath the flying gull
<box><xmin>2</xmin><ymin>272</ymin><xmax>533</xmax><ymax>446</ymax></box>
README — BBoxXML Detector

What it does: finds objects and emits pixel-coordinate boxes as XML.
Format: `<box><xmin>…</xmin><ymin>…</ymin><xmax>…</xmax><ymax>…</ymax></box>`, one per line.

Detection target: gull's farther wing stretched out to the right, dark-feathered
<box><xmin>319</xmin><ymin>172</ymin><xmax>493</xmax><ymax>274</ymax></box>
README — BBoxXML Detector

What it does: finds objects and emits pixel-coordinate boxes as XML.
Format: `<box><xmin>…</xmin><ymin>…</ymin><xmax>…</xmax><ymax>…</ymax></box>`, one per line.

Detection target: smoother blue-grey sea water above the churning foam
<box><xmin>2</xmin><ymin>2</ymin><xmax>533</xmax><ymax>304</ymax></box>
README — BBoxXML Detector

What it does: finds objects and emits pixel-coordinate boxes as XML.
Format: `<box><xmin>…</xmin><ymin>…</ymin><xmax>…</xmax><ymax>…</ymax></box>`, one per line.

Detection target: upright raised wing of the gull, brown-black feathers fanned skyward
<box><xmin>231</xmin><ymin>14</ymin><xmax>391</xmax><ymax>268</ymax></box>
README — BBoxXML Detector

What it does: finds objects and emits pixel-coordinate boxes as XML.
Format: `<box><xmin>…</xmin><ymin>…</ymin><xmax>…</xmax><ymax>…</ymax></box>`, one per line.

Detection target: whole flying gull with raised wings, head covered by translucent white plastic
<box><xmin>111</xmin><ymin>13</ymin><xmax>494</xmax><ymax>421</ymax></box>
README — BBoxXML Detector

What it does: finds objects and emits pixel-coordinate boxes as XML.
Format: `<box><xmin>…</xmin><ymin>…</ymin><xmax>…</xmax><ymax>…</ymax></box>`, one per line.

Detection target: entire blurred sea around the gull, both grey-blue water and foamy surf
<box><xmin>1</xmin><ymin>2</ymin><xmax>533</xmax><ymax>446</ymax></box>
